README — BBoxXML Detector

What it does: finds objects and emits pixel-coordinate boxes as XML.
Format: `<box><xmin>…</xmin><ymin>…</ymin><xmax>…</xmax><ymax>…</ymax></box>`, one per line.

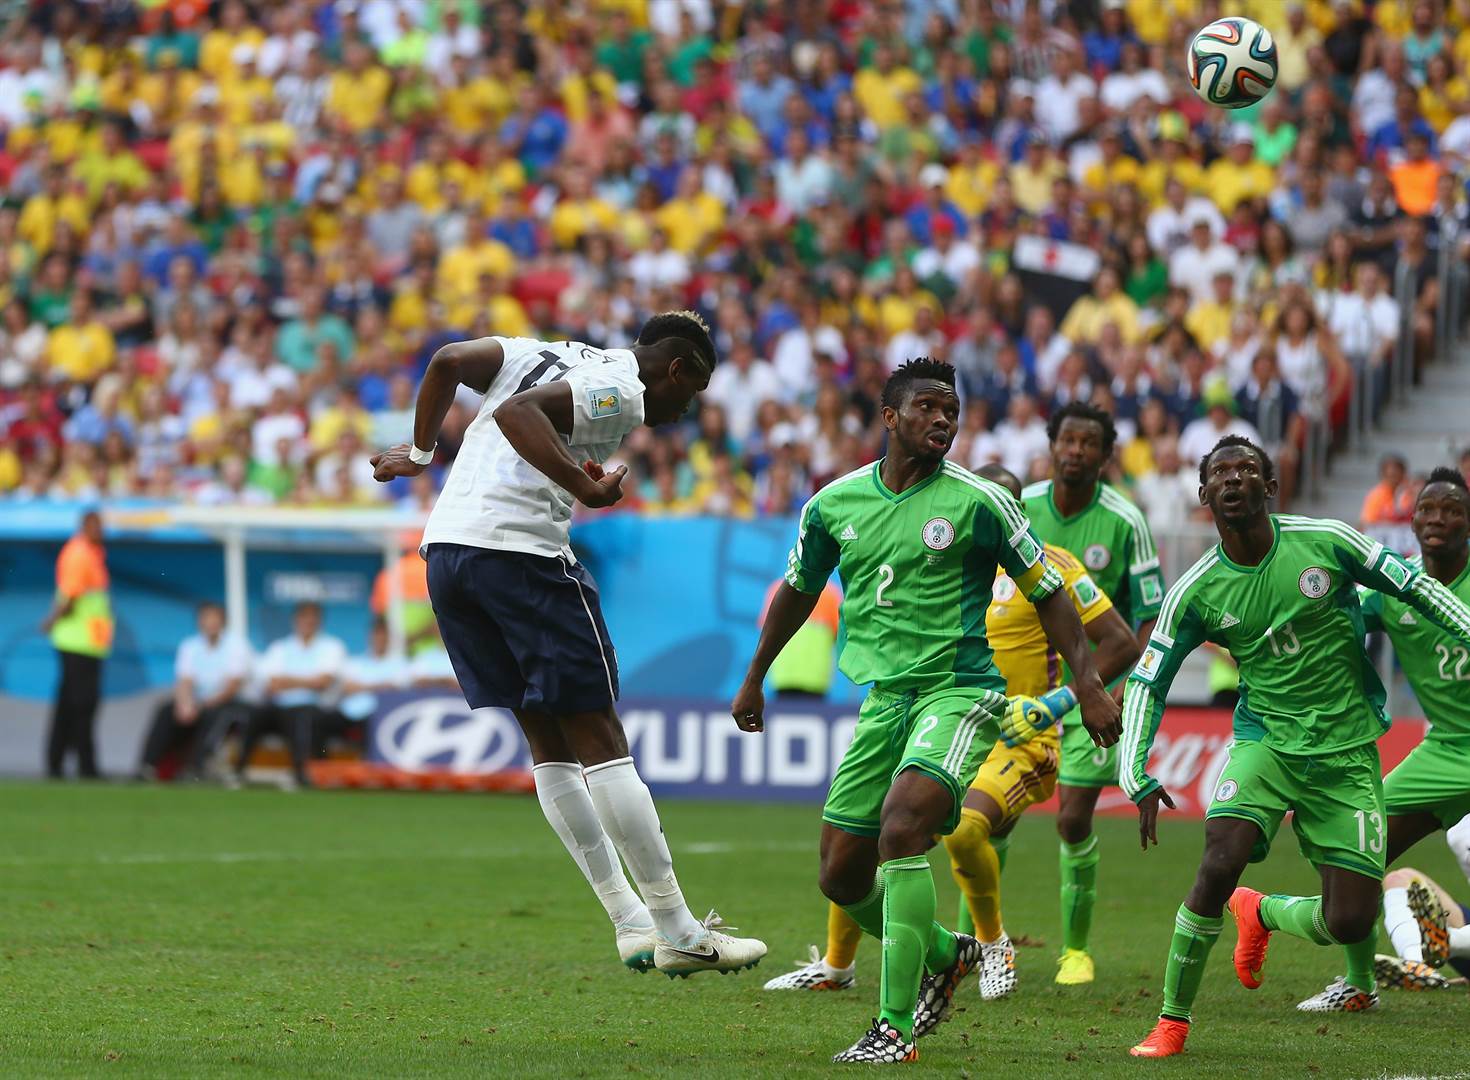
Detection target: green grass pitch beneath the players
<box><xmin>0</xmin><ymin>783</ymin><xmax>1470</xmax><ymax>1080</ymax></box>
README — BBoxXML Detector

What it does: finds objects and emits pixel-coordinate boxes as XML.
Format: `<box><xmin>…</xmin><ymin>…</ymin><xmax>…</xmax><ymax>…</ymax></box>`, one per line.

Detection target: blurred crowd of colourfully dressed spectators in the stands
<box><xmin>0</xmin><ymin>0</ymin><xmax>1470</xmax><ymax>528</ymax></box>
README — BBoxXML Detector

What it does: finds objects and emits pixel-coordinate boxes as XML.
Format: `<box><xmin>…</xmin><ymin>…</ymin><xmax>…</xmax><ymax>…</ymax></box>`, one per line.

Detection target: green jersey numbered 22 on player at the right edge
<box><xmin>1358</xmin><ymin>555</ymin><xmax>1470</xmax><ymax>741</ymax></box>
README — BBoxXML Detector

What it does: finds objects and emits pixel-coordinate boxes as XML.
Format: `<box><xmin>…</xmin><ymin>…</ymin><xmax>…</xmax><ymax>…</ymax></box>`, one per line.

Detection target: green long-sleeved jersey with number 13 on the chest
<box><xmin>1119</xmin><ymin>514</ymin><xmax>1470</xmax><ymax>801</ymax></box>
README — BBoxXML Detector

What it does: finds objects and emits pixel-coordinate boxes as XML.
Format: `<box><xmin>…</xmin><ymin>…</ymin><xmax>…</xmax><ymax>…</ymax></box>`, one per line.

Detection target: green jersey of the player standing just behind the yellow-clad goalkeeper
<box><xmin>1020</xmin><ymin>480</ymin><xmax>1164</xmax><ymax>627</ymax></box>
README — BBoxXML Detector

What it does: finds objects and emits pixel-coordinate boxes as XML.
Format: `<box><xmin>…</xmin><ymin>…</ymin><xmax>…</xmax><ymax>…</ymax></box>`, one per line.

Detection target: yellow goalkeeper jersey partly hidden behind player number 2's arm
<box><xmin>985</xmin><ymin>544</ymin><xmax>1113</xmax><ymax>696</ymax></box>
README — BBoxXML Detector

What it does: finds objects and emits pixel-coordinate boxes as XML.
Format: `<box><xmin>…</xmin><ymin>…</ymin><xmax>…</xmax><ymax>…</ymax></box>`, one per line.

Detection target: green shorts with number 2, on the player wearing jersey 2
<box><xmin>822</xmin><ymin>686</ymin><xmax>1005</xmax><ymax>836</ymax></box>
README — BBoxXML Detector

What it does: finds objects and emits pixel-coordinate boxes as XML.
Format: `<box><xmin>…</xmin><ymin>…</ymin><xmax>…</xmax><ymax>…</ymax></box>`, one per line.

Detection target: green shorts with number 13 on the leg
<box><xmin>1205</xmin><ymin>741</ymin><xmax>1386</xmax><ymax>880</ymax></box>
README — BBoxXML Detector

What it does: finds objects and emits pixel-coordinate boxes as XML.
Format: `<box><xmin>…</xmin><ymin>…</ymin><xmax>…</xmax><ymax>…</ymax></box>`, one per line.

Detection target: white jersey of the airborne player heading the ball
<box><xmin>423</xmin><ymin>338</ymin><xmax>644</xmax><ymax>561</ymax></box>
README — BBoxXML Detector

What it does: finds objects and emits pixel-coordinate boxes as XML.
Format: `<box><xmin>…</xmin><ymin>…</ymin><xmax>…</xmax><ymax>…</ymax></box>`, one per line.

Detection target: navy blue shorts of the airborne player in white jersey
<box><xmin>425</xmin><ymin>544</ymin><xmax>617</xmax><ymax>714</ymax></box>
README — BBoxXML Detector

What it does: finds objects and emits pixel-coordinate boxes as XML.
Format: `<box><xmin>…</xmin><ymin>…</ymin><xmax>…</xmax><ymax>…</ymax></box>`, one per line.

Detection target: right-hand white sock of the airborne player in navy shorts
<box><xmin>582</xmin><ymin>758</ymin><xmax>704</xmax><ymax>945</ymax></box>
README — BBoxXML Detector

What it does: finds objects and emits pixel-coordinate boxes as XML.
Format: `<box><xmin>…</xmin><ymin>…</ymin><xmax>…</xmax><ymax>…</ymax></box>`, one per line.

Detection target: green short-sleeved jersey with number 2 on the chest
<box><xmin>786</xmin><ymin>461</ymin><xmax>1061</xmax><ymax>694</ymax></box>
